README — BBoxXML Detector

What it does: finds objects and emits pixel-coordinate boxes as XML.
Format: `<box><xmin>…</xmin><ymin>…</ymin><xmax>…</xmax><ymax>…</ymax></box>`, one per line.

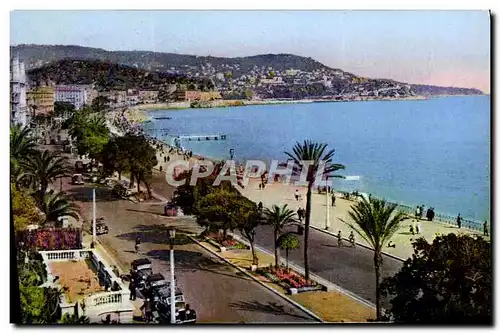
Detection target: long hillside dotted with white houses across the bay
<box><xmin>11</xmin><ymin>44</ymin><xmax>483</xmax><ymax>99</ymax></box>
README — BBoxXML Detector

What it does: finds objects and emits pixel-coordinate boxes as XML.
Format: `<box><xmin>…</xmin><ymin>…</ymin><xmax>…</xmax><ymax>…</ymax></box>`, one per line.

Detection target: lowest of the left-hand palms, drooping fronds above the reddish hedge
<box><xmin>40</xmin><ymin>190</ymin><xmax>80</xmax><ymax>225</ymax></box>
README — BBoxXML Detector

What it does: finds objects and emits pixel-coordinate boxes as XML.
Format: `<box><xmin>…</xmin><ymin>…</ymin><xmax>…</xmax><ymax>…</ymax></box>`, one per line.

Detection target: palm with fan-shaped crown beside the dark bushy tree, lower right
<box><xmin>340</xmin><ymin>197</ymin><xmax>408</xmax><ymax>320</ymax></box>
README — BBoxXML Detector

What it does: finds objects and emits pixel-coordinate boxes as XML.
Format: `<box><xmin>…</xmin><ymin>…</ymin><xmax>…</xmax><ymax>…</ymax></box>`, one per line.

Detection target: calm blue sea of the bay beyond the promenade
<box><xmin>144</xmin><ymin>96</ymin><xmax>491</xmax><ymax>220</ymax></box>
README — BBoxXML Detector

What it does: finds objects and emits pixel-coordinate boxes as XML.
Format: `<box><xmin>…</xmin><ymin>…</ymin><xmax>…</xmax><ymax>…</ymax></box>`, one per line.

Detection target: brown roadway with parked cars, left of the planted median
<box><xmin>58</xmin><ymin>174</ymin><xmax>315</xmax><ymax>323</ymax></box>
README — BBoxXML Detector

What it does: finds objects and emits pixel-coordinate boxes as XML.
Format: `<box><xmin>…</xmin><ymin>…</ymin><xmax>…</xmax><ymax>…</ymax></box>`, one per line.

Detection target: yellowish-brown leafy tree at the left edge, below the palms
<box><xmin>10</xmin><ymin>184</ymin><xmax>42</xmax><ymax>231</ymax></box>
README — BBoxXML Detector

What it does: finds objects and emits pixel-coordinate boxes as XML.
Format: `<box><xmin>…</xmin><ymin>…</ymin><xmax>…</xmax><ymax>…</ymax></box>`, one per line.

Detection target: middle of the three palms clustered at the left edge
<box><xmin>22</xmin><ymin>150</ymin><xmax>70</xmax><ymax>203</ymax></box>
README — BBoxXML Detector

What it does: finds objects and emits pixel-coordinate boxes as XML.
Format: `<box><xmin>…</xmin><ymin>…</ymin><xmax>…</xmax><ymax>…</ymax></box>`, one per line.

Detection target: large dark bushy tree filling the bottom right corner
<box><xmin>381</xmin><ymin>233</ymin><xmax>493</xmax><ymax>325</ymax></box>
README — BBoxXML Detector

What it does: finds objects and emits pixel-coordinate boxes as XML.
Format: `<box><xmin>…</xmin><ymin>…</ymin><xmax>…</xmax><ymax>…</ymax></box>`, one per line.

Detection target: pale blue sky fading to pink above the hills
<box><xmin>10</xmin><ymin>10</ymin><xmax>490</xmax><ymax>93</ymax></box>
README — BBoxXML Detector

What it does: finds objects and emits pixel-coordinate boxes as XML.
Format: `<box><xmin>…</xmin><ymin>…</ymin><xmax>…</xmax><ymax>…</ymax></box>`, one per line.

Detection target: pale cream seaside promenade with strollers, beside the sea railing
<box><xmin>240</xmin><ymin>180</ymin><xmax>488</xmax><ymax>259</ymax></box>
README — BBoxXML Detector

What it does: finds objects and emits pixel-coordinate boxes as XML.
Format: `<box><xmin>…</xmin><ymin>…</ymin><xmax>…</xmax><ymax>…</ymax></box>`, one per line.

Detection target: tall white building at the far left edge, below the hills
<box><xmin>10</xmin><ymin>57</ymin><xmax>30</xmax><ymax>126</ymax></box>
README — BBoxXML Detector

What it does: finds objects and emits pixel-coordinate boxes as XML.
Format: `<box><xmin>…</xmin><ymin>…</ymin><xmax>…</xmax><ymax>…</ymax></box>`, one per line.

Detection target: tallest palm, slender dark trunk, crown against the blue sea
<box><xmin>285</xmin><ymin>140</ymin><xmax>345</xmax><ymax>279</ymax></box>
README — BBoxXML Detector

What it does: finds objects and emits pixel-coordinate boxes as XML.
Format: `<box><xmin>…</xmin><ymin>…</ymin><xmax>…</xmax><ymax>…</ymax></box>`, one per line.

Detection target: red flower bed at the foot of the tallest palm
<box><xmin>256</xmin><ymin>266</ymin><xmax>325</xmax><ymax>294</ymax></box>
